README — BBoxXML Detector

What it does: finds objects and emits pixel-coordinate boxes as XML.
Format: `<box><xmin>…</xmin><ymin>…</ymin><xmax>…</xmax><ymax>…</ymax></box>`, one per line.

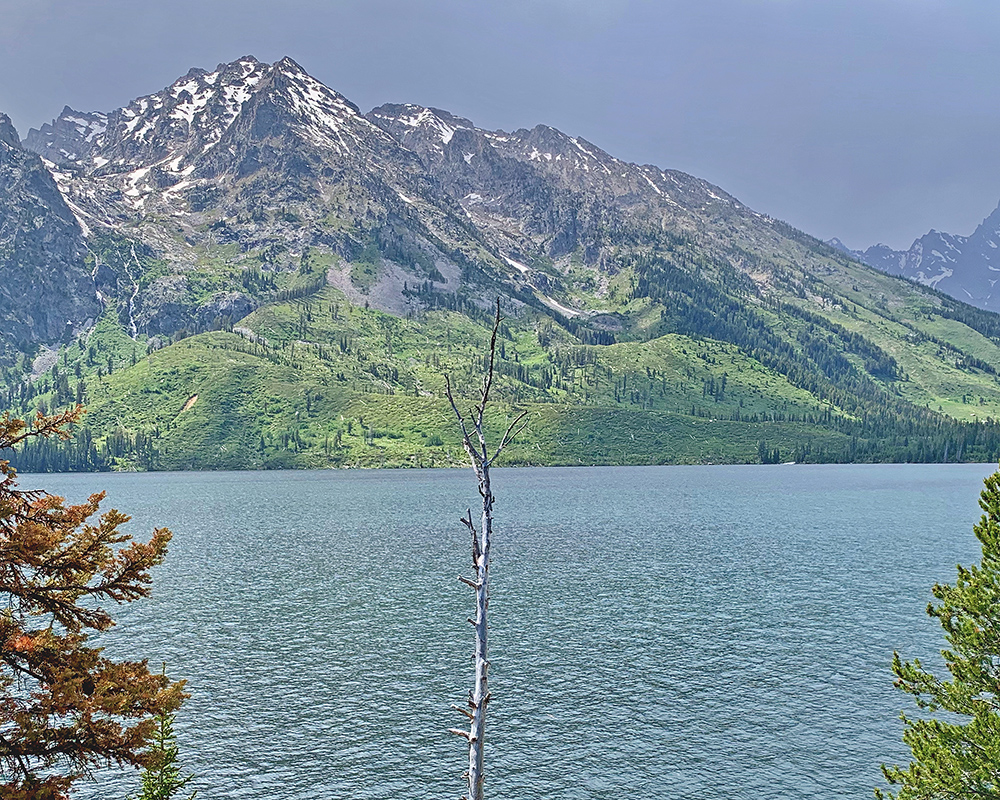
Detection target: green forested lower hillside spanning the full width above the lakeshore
<box><xmin>9</xmin><ymin>256</ymin><xmax>1000</xmax><ymax>469</ymax></box>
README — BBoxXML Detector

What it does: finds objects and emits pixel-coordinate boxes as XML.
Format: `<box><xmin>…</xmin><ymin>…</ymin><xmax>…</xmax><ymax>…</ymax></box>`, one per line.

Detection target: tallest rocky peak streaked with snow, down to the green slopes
<box><xmin>18</xmin><ymin>56</ymin><xmax>468</xmax><ymax>334</ymax></box>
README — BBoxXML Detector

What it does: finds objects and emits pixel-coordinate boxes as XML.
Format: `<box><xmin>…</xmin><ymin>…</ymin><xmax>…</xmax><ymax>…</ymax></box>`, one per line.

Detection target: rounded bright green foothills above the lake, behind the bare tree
<box><xmin>72</xmin><ymin>288</ymin><xmax>842</xmax><ymax>469</ymax></box>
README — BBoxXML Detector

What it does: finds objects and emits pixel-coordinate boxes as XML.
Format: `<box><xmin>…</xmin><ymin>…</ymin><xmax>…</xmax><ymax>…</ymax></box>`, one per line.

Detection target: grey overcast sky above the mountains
<box><xmin>0</xmin><ymin>0</ymin><xmax>1000</xmax><ymax>247</ymax></box>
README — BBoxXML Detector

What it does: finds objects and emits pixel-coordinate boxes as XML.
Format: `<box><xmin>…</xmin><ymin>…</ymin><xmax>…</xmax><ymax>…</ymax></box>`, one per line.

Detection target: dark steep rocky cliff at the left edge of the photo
<box><xmin>0</xmin><ymin>114</ymin><xmax>100</xmax><ymax>356</ymax></box>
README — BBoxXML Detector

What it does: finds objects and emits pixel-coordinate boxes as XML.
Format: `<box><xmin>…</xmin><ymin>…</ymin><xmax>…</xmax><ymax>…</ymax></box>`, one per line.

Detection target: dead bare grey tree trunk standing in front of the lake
<box><xmin>445</xmin><ymin>298</ymin><xmax>527</xmax><ymax>800</ymax></box>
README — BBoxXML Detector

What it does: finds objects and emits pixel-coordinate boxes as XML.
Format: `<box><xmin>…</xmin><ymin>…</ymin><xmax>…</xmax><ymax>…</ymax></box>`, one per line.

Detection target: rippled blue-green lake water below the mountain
<box><xmin>22</xmin><ymin>465</ymin><xmax>990</xmax><ymax>800</ymax></box>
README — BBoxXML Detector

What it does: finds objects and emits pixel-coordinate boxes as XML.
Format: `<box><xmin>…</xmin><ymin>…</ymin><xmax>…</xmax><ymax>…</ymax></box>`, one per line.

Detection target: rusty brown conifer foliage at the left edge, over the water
<box><xmin>0</xmin><ymin>407</ymin><xmax>185</xmax><ymax>800</ymax></box>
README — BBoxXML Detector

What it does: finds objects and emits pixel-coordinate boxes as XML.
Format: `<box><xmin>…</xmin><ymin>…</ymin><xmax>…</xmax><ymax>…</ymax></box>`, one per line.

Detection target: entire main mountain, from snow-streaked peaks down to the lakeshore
<box><xmin>0</xmin><ymin>56</ymin><xmax>1000</xmax><ymax>469</ymax></box>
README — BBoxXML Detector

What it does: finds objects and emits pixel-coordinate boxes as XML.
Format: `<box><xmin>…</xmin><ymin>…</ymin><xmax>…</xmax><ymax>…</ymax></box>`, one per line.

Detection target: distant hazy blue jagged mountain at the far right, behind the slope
<box><xmin>829</xmin><ymin>206</ymin><xmax>1000</xmax><ymax>311</ymax></box>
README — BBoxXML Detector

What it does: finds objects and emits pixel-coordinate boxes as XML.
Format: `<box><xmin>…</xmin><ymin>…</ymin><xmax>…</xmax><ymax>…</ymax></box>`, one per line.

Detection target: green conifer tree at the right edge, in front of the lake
<box><xmin>875</xmin><ymin>472</ymin><xmax>1000</xmax><ymax>800</ymax></box>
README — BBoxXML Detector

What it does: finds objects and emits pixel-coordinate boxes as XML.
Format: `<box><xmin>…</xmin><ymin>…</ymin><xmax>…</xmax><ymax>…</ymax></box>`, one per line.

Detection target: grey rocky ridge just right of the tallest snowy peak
<box><xmin>368</xmin><ymin>105</ymin><xmax>744</xmax><ymax>264</ymax></box>
